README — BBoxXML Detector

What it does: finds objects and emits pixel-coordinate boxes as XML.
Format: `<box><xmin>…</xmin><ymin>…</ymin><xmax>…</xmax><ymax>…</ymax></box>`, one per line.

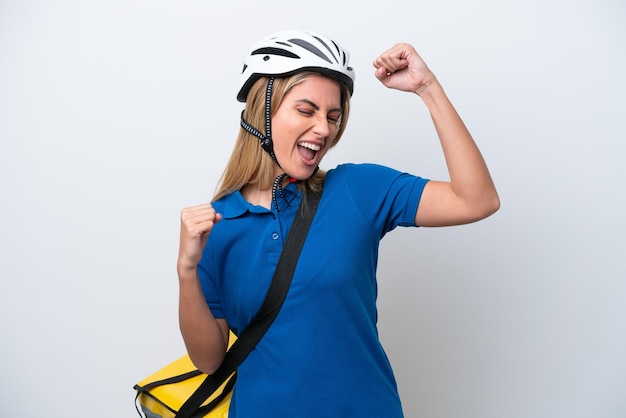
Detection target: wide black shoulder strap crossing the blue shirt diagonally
<box><xmin>175</xmin><ymin>193</ymin><xmax>321</xmax><ymax>418</ymax></box>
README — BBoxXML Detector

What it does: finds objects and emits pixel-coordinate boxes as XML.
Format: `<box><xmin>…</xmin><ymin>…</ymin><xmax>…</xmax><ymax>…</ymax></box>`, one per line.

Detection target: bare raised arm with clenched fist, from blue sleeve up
<box><xmin>374</xmin><ymin>43</ymin><xmax>500</xmax><ymax>227</ymax></box>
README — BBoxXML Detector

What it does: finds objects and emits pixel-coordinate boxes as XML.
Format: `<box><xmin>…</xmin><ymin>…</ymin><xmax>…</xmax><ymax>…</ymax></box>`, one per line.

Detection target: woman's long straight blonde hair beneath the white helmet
<box><xmin>212</xmin><ymin>72</ymin><xmax>350</xmax><ymax>201</ymax></box>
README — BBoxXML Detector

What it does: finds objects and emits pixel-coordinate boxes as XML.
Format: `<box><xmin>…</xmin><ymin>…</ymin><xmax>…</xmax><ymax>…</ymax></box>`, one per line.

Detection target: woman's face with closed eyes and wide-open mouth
<box><xmin>272</xmin><ymin>75</ymin><xmax>341</xmax><ymax>180</ymax></box>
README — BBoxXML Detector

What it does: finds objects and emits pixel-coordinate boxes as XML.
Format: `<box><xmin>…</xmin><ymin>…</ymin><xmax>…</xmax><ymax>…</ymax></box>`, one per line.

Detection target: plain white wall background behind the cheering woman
<box><xmin>0</xmin><ymin>0</ymin><xmax>626</xmax><ymax>418</ymax></box>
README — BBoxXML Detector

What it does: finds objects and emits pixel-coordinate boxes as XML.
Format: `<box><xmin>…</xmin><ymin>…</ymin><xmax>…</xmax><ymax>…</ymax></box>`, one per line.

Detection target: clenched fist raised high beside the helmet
<box><xmin>373</xmin><ymin>43</ymin><xmax>435</xmax><ymax>94</ymax></box>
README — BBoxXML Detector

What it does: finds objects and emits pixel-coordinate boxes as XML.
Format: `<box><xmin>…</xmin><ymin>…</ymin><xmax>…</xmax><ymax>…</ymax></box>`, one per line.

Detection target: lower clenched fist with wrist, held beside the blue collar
<box><xmin>178</xmin><ymin>203</ymin><xmax>222</xmax><ymax>272</ymax></box>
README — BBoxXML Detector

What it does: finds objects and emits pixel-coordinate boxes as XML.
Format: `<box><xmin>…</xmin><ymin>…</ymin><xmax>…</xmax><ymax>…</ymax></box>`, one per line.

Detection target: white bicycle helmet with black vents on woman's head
<box><xmin>237</xmin><ymin>30</ymin><xmax>355</xmax><ymax>102</ymax></box>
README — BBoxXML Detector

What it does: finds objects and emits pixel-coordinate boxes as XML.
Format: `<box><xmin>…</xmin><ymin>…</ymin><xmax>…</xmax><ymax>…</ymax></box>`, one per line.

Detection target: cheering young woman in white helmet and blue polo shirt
<box><xmin>178</xmin><ymin>31</ymin><xmax>499</xmax><ymax>418</ymax></box>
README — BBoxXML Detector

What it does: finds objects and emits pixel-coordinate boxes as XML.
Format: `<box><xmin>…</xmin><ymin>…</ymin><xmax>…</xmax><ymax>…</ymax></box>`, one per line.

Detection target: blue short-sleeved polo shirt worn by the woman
<box><xmin>199</xmin><ymin>164</ymin><xmax>427</xmax><ymax>418</ymax></box>
